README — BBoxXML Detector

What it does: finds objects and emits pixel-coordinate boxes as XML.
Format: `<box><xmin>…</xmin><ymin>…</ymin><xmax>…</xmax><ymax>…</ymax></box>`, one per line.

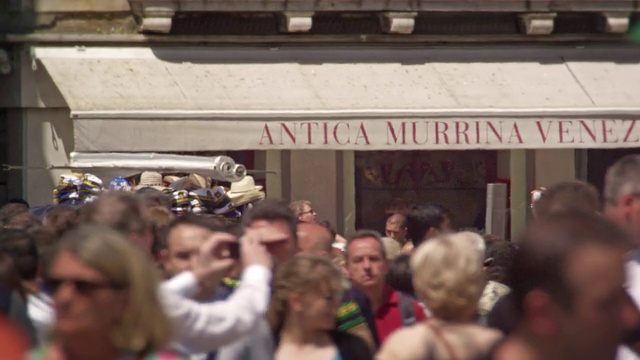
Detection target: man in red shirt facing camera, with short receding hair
<box><xmin>346</xmin><ymin>230</ymin><xmax>425</xmax><ymax>344</ymax></box>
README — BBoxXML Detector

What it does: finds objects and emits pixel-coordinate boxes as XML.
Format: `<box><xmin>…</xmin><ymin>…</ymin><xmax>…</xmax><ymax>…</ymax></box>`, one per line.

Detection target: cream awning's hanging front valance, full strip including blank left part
<box><xmin>74</xmin><ymin>118</ymin><xmax>640</xmax><ymax>151</ymax></box>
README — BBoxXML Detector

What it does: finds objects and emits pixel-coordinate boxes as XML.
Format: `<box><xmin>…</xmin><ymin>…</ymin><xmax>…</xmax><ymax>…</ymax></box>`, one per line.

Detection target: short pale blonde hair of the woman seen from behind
<box><xmin>411</xmin><ymin>232</ymin><xmax>486</xmax><ymax>320</ymax></box>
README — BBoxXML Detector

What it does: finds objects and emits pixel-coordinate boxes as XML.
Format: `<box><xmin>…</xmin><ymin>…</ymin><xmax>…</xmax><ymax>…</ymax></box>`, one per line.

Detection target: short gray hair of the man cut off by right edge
<box><xmin>604</xmin><ymin>155</ymin><xmax>640</xmax><ymax>204</ymax></box>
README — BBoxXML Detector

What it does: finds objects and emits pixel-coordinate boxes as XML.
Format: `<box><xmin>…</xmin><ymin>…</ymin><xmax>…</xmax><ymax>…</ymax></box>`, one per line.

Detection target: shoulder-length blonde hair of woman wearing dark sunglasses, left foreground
<box><xmin>51</xmin><ymin>226</ymin><xmax>171</xmax><ymax>356</ymax></box>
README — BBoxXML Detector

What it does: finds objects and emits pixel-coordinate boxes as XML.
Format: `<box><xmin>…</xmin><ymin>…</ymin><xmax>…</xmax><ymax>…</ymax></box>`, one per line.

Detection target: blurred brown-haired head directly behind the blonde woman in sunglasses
<box><xmin>78</xmin><ymin>191</ymin><xmax>153</xmax><ymax>254</ymax></box>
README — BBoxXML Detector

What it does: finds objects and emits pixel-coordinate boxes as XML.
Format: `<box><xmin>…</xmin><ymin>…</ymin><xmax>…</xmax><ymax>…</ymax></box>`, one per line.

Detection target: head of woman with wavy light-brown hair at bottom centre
<box><xmin>268</xmin><ymin>255</ymin><xmax>343</xmax><ymax>333</ymax></box>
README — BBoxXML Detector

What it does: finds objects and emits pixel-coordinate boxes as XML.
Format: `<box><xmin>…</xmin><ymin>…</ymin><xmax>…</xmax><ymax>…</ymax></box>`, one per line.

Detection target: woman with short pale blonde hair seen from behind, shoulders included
<box><xmin>376</xmin><ymin>232</ymin><xmax>501</xmax><ymax>360</ymax></box>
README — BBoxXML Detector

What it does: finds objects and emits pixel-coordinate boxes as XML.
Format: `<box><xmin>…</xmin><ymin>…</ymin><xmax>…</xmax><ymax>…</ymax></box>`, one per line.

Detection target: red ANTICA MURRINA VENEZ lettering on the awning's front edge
<box><xmin>258</xmin><ymin>119</ymin><xmax>640</xmax><ymax>150</ymax></box>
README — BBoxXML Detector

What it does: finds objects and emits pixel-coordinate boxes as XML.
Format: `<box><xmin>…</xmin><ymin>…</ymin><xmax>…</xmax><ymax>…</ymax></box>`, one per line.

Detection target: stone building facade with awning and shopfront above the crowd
<box><xmin>0</xmin><ymin>0</ymin><xmax>640</xmax><ymax>238</ymax></box>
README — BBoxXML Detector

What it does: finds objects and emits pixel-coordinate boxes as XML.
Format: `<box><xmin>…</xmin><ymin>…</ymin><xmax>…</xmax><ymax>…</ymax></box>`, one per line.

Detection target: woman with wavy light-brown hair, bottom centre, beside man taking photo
<box><xmin>268</xmin><ymin>255</ymin><xmax>372</xmax><ymax>360</ymax></box>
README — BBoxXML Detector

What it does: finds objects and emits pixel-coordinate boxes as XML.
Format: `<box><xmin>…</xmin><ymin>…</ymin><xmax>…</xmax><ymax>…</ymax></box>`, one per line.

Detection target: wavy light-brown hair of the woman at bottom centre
<box><xmin>267</xmin><ymin>255</ymin><xmax>343</xmax><ymax>333</ymax></box>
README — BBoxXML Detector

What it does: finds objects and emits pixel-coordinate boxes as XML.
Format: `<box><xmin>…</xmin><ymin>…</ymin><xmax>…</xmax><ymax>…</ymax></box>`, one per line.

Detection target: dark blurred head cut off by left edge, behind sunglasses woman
<box><xmin>0</xmin><ymin>229</ymin><xmax>39</xmax><ymax>280</ymax></box>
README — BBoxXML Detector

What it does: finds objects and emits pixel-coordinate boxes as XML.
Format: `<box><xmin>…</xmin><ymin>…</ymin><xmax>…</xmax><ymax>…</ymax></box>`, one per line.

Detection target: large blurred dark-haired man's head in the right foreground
<box><xmin>512</xmin><ymin>212</ymin><xmax>639</xmax><ymax>359</ymax></box>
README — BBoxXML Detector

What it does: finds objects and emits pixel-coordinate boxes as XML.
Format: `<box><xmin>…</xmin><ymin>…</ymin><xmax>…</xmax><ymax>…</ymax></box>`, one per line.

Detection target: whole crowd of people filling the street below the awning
<box><xmin>0</xmin><ymin>155</ymin><xmax>640</xmax><ymax>360</ymax></box>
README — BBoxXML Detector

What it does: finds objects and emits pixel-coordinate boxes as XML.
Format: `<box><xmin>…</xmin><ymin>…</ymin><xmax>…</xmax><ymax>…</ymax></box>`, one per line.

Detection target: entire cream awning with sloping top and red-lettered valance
<box><xmin>35</xmin><ymin>47</ymin><xmax>640</xmax><ymax>152</ymax></box>
